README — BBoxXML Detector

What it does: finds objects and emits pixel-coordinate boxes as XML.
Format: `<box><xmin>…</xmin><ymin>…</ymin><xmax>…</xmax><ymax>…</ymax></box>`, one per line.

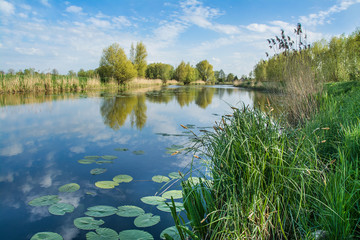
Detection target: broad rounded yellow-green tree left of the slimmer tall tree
<box><xmin>98</xmin><ymin>43</ymin><xmax>137</xmax><ymax>85</ymax></box>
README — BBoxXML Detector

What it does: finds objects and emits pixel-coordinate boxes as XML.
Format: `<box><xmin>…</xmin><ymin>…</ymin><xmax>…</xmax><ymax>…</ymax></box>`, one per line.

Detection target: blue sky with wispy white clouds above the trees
<box><xmin>0</xmin><ymin>0</ymin><xmax>360</xmax><ymax>76</ymax></box>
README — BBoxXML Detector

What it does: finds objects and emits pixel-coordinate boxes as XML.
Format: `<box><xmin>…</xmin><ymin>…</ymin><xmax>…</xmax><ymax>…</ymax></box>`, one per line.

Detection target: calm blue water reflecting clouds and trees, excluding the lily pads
<box><xmin>0</xmin><ymin>86</ymin><xmax>276</xmax><ymax>239</ymax></box>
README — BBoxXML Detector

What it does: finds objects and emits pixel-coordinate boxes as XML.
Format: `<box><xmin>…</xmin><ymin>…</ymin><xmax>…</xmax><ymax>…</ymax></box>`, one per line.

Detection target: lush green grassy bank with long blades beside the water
<box><xmin>173</xmin><ymin>82</ymin><xmax>360</xmax><ymax>239</ymax></box>
